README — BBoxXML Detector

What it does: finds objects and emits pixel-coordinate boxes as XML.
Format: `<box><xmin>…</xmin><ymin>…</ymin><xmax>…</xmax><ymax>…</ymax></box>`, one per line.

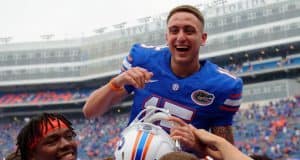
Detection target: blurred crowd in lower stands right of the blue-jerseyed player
<box><xmin>234</xmin><ymin>98</ymin><xmax>300</xmax><ymax>159</ymax></box>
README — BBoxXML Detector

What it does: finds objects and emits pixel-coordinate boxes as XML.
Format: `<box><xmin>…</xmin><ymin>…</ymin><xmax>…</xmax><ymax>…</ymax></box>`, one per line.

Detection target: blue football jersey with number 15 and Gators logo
<box><xmin>122</xmin><ymin>44</ymin><xmax>243</xmax><ymax>130</ymax></box>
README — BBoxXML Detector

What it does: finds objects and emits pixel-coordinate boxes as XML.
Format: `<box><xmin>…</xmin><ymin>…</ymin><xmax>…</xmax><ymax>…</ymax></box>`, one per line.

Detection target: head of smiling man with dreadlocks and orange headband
<box><xmin>17</xmin><ymin>113</ymin><xmax>77</xmax><ymax>160</ymax></box>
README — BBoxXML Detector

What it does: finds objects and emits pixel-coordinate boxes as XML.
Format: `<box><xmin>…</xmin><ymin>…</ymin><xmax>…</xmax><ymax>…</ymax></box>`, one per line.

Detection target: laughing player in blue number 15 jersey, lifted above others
<box><xmin>83</xmin><ymin>5</ymin><xmax>243</xmax><ymax>157</ymax></box>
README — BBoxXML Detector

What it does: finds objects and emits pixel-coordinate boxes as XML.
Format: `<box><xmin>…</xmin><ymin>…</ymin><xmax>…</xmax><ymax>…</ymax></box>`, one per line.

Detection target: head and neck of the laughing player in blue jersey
<box><xmin>166</xmin><ymin>5</ymin><xmax>207</xmax><ymax>71</ymax></box>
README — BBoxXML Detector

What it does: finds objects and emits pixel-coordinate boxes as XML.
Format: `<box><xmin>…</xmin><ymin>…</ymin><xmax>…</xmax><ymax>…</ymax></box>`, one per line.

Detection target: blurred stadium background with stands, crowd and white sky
<box><xmin>0</xmin><ymin>0</ymin><xmax>300</xmax><ymax>160</ymax></box>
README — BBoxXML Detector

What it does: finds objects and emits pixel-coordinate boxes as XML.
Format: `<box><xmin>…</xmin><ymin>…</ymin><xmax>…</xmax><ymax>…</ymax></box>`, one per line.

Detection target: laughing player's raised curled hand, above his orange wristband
<box><xmin>113</xmin><ymin>67</ymin><xmax>153</xmax><ymax>88</ymax></box>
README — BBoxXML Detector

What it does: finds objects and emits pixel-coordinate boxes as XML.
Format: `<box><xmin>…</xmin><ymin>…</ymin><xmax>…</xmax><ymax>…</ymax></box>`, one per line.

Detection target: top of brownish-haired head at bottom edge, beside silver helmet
<box><xmin>159</xmin><ymin>151</ymin><xmax>198</xmax><ymax>160</ymax></box>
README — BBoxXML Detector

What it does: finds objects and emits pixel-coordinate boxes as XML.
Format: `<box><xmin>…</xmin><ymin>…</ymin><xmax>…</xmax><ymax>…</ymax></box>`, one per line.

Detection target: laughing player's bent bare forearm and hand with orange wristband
<box><xmin>83</xmin><ymin>67</ymin><xmax>153</xmax><ymax>118</ymax></box>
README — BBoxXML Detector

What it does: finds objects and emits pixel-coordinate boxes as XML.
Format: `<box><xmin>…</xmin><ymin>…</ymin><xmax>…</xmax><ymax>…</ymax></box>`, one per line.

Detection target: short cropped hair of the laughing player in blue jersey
<box><xmin>167</xmin><ymin>5</ymin><xmax>205</xmax><ymax>26</ymax></box>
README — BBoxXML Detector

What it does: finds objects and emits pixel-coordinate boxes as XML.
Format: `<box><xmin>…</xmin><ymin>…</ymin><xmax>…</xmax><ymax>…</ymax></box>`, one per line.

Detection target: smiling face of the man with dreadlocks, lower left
<box><xmin>31</xmin><ymin>128</ymin><xmax>77</xmax><ymax>160</ymax></box>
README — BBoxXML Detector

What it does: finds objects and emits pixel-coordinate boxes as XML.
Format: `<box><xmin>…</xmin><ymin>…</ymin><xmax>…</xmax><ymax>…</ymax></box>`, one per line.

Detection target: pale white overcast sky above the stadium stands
<box><xmin>0</xmin><ymin>0</ymin><xmax>206</xmax><ymax>43</ymax></box>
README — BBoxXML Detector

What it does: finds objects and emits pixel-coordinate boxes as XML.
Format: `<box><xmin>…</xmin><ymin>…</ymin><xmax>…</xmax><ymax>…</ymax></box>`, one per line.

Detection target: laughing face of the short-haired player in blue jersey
<box><xmin>166</xmin><ymin>12</ymin><xmax>207</xmax><ymax>65</ymax></box>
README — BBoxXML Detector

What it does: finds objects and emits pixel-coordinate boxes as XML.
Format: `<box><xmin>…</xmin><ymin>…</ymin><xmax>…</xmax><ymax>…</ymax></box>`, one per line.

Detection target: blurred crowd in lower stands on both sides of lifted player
<box><xmin>0</xmin><ymin>97</ymin><xmax>300</xmax><ymax>160</ymax></box>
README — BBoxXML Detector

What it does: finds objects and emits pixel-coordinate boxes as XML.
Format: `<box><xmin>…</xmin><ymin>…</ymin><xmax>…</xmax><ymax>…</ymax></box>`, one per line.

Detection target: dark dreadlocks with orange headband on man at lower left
<box><xmin>17</xmin><ymin>113</ymin><xmax>75</xmax><ymax>160</ymax></box>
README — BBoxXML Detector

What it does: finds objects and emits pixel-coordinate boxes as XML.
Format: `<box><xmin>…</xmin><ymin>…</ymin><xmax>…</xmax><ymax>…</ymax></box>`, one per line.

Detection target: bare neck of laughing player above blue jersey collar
<box><xmin>171</xmin><ymin>61</ymin><xmax>201</xmax><ymax>78</ymax></box>
